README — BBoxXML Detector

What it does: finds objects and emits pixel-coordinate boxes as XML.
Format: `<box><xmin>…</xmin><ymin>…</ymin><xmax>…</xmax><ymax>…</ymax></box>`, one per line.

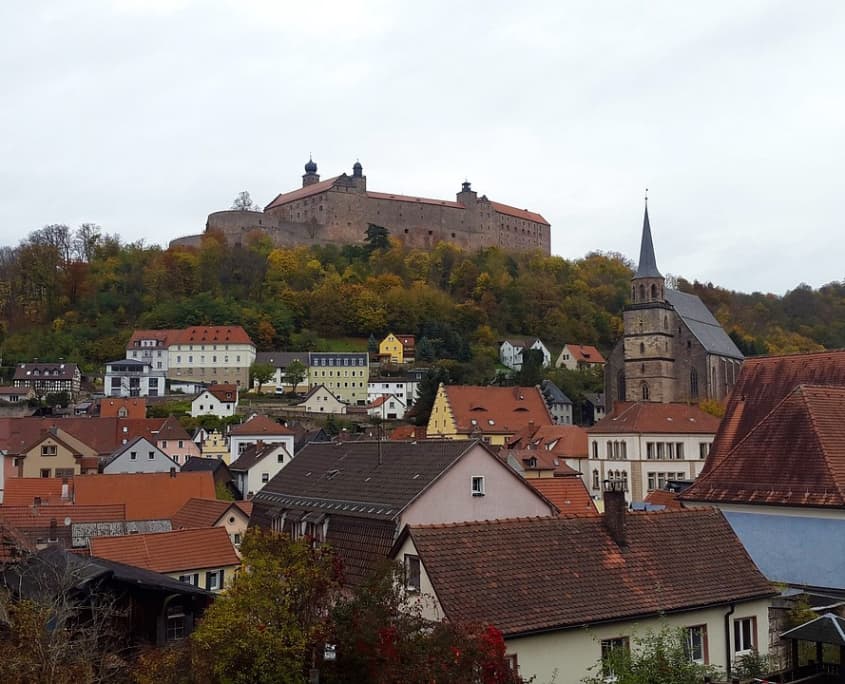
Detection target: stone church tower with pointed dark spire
<box><xmin>617</xmin><ymin>197</ymin><xmax>677</xmax><ymax>403</ymax></box>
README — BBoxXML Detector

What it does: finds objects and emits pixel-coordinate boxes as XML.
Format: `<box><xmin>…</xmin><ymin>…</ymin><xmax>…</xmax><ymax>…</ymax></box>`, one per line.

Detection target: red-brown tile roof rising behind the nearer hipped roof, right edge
<box><xmin>703</xmin><ymin>350</ymin><xmax>845</xmax><ymax>473</ymax></box>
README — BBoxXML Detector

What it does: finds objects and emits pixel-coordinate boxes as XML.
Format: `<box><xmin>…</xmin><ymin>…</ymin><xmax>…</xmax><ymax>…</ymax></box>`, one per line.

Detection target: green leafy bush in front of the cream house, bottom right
<box><xmin>581</xmin><ymin>627</ymin><xmax>717</xmax><ymax>684</ymax></box>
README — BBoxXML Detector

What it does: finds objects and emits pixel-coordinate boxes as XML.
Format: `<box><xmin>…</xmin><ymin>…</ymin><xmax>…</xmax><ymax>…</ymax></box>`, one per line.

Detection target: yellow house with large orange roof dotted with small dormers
<box><xmin>427</xmin><ymin>384</ymin><xmax>554</xmax><ymax>446</ymax></box>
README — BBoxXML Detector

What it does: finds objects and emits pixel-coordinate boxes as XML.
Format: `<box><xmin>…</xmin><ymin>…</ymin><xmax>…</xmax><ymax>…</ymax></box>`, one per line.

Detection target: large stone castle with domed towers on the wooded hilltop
<box><xmin>170</xmin><ymin>160</ymin><xmax>551</xmax><ymax>254</ymax></box>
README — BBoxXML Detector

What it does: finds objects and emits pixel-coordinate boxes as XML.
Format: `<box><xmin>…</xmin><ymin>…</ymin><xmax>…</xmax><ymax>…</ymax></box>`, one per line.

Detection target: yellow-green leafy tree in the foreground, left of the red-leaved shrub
<box><xmin>191</xmin><ymin>529</ymin><xmax>340</xmax><ymax>684</ymax></box>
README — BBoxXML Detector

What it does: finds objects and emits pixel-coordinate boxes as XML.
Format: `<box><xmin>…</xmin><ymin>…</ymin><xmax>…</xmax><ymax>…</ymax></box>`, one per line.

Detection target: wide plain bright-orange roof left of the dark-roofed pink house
<box><xmin>73</xmin><ymin>471</ymin><xmax>215</xmax><ymax>520</ymax></box>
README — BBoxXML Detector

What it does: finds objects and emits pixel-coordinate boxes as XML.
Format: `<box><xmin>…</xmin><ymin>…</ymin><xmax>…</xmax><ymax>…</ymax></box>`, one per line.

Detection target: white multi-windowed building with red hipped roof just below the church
<box><xmin>582</xmin><ymin>402</ymin><xmax>719</xmax><ymax>501</ymax></box>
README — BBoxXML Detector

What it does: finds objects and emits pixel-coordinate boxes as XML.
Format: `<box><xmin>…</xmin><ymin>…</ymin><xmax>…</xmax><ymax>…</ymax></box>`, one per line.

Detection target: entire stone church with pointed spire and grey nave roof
<box><xmin>605</xmin><ymin>200</ymin><xmax>743</xmax><ymax>403</ymax></box>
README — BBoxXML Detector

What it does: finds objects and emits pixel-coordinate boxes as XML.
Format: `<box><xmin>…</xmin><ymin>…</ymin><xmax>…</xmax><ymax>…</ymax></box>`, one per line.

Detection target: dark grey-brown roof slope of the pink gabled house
<box><xmin>251</xmin><ymin>440</ymin><xmax>476</xmax><ymax>520</ymax></box>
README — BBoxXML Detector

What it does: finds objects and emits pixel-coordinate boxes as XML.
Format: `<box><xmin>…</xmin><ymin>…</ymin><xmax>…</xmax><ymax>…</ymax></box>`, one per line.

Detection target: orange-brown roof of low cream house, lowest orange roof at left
<box><xmin>90</xmin><ymin>527</ymin><xmax>240</xmax><ymax>572</ymax></box>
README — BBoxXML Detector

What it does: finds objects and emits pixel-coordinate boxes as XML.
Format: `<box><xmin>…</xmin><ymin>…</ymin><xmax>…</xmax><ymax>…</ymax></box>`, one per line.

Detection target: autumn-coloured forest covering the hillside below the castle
<box><xmin>0</xmin><ymin>224</ymin><xmax>845</xmax><ymax>382</ymax></box>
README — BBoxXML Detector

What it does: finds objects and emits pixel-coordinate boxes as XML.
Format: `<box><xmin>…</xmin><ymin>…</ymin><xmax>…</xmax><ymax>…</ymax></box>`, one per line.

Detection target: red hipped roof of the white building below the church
<box><xmin>587</xmin><ymin>401</ymin><xmax>720</xmax><ymax>435</ymax></box>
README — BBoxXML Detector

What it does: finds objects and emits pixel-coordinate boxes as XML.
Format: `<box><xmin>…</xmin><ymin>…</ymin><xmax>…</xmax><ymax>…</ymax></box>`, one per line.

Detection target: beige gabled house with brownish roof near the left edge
<box><xmin>14</xmin><ymin>428</ymin><xmax>99</xmax><ymax>477</ymax></box>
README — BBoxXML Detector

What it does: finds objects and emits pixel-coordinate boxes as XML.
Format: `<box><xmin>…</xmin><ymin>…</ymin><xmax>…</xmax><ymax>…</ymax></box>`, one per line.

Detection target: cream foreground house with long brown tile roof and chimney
<box><xmin>391</xmin><ymin>497</ymin><xmax>775</xmax><ymax>684</ymax></box>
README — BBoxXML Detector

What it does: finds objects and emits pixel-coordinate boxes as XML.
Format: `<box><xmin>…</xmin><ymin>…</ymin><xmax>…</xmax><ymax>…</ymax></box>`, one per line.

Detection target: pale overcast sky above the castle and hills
<box><xmin>0</xmin><ymin>0</ymin><xmax>845</xmax><ymax>294</ymax></box>
